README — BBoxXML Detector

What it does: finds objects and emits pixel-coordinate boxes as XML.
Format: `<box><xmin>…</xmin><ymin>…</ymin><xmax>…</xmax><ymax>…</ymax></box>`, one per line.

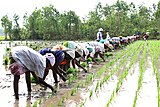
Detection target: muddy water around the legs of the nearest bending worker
<box><xmin>0</xmin><ymin>41</ymin><xmax>61</xmax><ymax>107</ymax></box>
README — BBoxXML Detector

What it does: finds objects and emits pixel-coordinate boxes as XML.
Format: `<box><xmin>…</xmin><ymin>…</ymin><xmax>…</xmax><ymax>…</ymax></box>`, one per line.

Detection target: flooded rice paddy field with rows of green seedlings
<box><xmin>0</xmin><ymin>40</ymin><xmax>160</xmax><ymax>107</ymax></box>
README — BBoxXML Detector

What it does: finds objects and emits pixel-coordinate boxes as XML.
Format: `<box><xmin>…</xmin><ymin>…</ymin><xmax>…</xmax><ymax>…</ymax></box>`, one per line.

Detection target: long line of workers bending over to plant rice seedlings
<box><xmin>9</xmin><ymin>28</ymin><xmax>140</xmax><ymax>99</ymax></box>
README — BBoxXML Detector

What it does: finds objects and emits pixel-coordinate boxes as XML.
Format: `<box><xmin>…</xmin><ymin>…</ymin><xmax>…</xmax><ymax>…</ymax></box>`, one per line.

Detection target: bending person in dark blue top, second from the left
<box><xmin>39</xmin><ymin>48</ymin><xmax>67</xmax><ymax>83</ymax></box>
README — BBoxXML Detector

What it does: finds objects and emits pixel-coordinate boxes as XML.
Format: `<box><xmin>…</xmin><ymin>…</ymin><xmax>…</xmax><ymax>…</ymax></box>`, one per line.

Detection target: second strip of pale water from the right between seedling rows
<box><xmin>110</xmin><ymin>63</ymin><xmax>139</xmax><ymax>107</ymax></box>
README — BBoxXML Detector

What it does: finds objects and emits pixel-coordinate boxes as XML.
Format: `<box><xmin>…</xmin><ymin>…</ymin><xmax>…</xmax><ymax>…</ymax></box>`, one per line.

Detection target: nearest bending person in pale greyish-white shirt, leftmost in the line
<box><xmin>9</xmin><ymin>46</ymin><xmax>54</xmax><ymax>99</ymax></box>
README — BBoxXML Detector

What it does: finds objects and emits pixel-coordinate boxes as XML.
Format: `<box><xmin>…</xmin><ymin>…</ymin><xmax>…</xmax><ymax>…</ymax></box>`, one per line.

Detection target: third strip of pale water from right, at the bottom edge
<box><xmin>78</xmin><ymin>76</ymin><xmax>117</xmax><ymax>107</ymax></box>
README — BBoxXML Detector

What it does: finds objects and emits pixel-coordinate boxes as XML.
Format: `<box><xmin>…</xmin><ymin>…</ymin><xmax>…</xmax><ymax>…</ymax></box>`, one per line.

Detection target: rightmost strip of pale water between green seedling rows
<box><xmin>137</xmin><ymin>57</ymin><xmax>158</xmax><ymax>107</ymax></box>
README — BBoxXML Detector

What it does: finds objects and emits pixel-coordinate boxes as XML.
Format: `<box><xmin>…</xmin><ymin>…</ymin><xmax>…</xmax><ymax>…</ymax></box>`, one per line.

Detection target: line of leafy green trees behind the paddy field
<box><xmin>1</xmin><ymin>0</ymin><xmax>160</xmax><ymax>40</ymax></box>
